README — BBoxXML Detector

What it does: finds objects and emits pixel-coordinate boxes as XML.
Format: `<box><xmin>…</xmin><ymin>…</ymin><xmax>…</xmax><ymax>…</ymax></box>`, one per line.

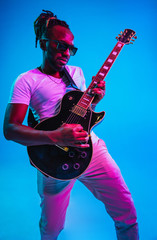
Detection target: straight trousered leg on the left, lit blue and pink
<box><xmin>38</xmin><ymin>172</ymin><xmax>75</xmax><ymax>240</ymax></box>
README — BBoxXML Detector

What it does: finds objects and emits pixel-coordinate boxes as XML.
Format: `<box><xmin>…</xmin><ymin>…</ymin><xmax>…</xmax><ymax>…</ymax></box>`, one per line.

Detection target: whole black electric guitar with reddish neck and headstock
<box><xmin>27</xmin><ymin>29</ymin><xmax>137</xmax><ymax>180</ymax></box>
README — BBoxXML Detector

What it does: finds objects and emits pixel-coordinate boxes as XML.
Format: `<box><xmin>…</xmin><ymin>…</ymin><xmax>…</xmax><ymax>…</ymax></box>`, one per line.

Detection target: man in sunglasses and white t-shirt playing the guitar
<box><xmin>4</xmin><ymin>11</ymin><xmax>138</xmax><ymax>240</ymax></box>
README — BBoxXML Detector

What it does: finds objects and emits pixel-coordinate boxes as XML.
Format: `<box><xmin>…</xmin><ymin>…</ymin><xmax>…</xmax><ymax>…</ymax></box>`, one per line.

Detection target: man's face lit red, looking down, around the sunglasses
<box><xmin>45</xmin><ymin>25</ymin><xmax>74</xmax><ymax>71</ymax></box>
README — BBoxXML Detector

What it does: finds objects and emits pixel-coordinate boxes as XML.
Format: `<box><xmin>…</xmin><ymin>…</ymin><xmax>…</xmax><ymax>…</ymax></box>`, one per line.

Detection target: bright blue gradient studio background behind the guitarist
<box><xmin>0</xmin><ymin>0</ymin><xmax>157</xmax><ymax>240</ymax></box>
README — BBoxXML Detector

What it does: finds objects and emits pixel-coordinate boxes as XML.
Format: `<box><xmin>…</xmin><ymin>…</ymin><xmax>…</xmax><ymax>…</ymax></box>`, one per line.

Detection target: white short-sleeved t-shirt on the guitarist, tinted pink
<box><xmin>9</xmin><ymin>66</ymin><xmax>98</xmax><ymax>142</ymax></box>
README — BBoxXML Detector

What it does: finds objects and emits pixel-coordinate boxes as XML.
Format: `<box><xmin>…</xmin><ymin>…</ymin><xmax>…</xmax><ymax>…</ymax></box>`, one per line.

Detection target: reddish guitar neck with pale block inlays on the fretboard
<box><xmin>77</xmin><ymin>41</ymin><xmax>125</xmax><ymax>109</ymax></box>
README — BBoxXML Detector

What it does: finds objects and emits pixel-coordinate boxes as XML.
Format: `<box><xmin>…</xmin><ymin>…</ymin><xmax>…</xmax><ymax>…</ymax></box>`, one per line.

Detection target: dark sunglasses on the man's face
<box><xmin>44</xmin><ymin>38</ymin><xmax>78</xmax><ymax>56</ymax></box>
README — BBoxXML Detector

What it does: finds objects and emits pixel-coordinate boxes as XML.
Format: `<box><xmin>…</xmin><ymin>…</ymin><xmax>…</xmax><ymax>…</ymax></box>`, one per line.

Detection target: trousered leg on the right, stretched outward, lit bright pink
<box><xmin>79</xmin><ymin>140</ymin><xmax>139</xmax><ymax>240</ymax></box>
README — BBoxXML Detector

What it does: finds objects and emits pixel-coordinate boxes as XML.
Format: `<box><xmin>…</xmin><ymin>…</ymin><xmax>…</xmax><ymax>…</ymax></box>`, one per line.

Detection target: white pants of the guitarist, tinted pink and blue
<box><xmin>38</xmin><ymin>139</ymin><xmax>139</xmax><ymax>240</ymax></box>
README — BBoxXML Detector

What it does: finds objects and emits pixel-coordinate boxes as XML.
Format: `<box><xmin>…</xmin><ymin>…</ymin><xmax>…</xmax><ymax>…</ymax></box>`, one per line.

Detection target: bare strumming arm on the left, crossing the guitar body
<box><xmin>4</xmin><ymin>103</ymin><xmax>89</xmax><ymax>147</ymax></box>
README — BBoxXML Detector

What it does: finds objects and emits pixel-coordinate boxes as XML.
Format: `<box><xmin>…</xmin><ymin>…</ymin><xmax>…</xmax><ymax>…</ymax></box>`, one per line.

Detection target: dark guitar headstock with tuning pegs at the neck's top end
<box><xmin>116</xmin><ymin>29</ymin><xmax>137</xmax><ymax>44</ymax></box>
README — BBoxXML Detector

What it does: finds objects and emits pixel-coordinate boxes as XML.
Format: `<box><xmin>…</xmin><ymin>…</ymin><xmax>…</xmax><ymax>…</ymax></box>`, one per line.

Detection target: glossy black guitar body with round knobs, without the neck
<box><xmin>27</xmin><ymin>90</ymin><xmax>105</xmax><ymax>180</ymax></box>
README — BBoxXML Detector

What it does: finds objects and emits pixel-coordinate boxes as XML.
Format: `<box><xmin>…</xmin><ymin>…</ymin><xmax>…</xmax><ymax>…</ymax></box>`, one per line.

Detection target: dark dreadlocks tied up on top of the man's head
<box><xmin>34</xmin><ymin>10</ymin><xmax>69</xmax><ymax>47</ymax></box>
